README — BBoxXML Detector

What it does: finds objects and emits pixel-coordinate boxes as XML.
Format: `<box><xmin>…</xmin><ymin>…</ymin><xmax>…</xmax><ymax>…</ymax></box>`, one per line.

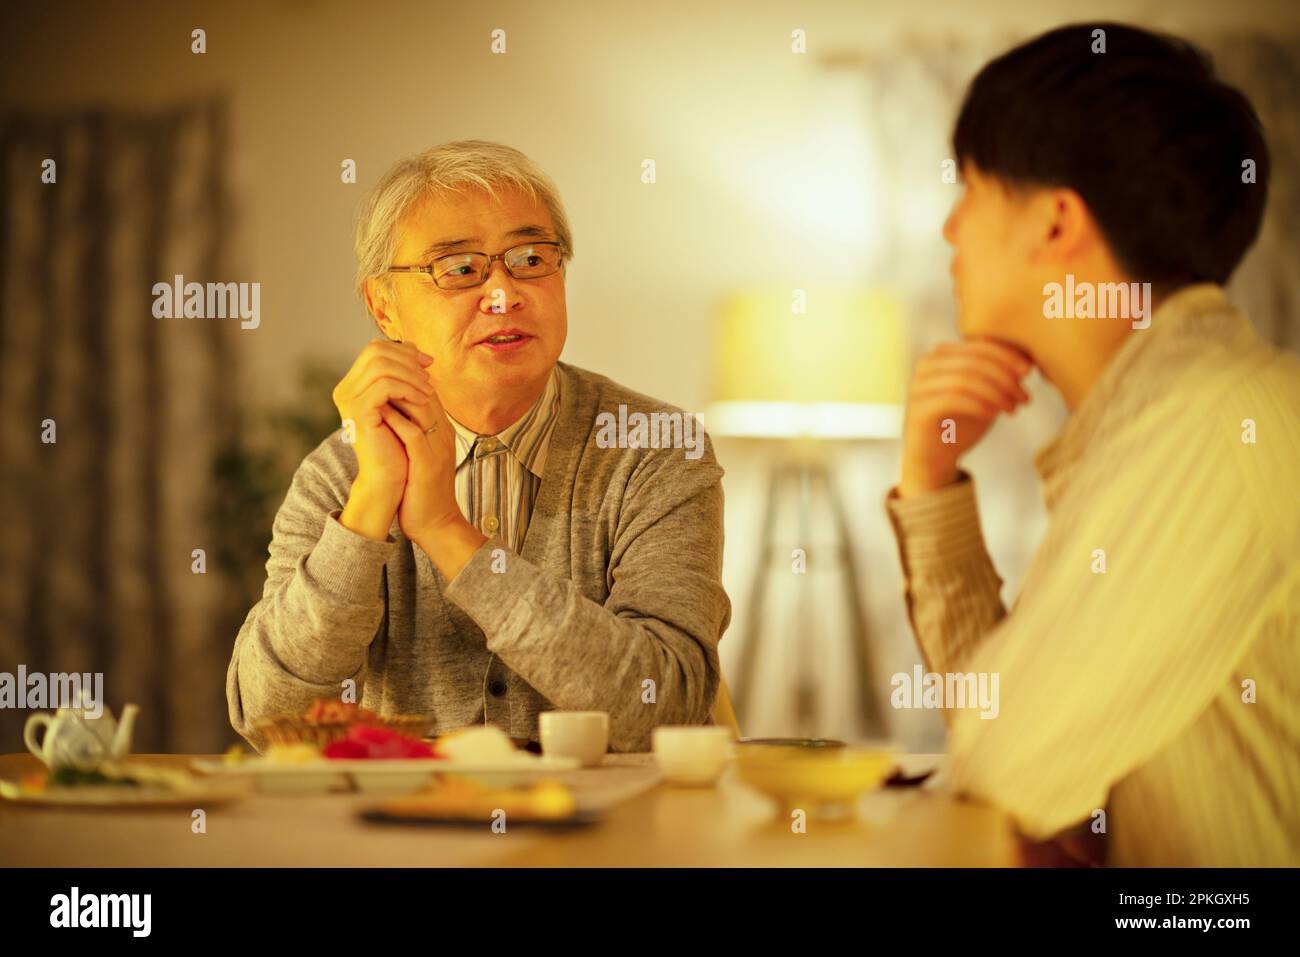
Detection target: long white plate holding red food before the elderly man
<box><xmin>190</xmin><ymin>752</ymin><xmax>579</xmax><ymax>794</ymax></box>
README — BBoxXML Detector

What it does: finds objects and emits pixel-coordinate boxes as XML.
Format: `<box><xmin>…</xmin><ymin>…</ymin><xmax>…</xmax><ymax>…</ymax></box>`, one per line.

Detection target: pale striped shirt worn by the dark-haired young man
<box><xmin>887</xmin><ymin>285</ymin><xmax>1300</xmax><ymax>866</ymax></box>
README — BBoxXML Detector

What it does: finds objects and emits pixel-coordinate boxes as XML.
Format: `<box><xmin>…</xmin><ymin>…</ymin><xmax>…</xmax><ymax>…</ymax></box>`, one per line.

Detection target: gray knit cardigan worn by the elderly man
<box><xmin>226</xmin><ymin>363</ymin><xmax>731</xmax><ymax>750</ymax></box>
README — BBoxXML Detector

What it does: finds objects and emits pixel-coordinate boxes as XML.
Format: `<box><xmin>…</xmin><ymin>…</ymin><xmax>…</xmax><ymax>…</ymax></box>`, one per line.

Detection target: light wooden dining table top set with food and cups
<box><xmin>0</xmin><ymin>754</ymin><xmax>1023</xmax><ymax>867</ymax></box>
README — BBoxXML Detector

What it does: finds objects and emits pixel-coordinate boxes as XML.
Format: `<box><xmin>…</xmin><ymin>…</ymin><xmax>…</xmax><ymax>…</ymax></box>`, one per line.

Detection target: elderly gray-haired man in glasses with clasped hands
<box><xmin>226</xmin><ymin>140</ymin><xmax>731</xmax><ymax>750</ymax></box>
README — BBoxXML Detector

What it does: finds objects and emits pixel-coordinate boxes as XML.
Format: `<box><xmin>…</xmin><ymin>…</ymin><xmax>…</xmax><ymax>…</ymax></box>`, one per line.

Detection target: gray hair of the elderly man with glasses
<box><xmin>356</xmin><ymin>139</ymin><xmax>573</xmax><ymax>302</ymax></box>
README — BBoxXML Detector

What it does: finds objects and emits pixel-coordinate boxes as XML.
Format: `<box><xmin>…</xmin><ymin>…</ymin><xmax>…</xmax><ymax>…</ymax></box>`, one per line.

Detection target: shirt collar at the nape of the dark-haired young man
<box><xmin>1034</xmin><ymin>282</ymin><xmax>1232</xmax><ymax>494</ymax></box>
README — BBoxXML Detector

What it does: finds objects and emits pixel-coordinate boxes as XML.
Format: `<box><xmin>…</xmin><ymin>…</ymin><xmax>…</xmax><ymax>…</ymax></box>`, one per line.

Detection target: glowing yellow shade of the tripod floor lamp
<box><xmin>707</xmin><ymin>287</ymin><xmax>909</xmax><ymax>438</ymax></box>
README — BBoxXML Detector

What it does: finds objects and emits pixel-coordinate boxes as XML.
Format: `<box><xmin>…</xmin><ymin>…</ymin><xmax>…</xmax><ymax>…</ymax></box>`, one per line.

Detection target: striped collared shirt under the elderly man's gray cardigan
<box><xmin>447</xmin><ymin>368</ymin><xmax>560</xmax><ymax>554</ymax></box>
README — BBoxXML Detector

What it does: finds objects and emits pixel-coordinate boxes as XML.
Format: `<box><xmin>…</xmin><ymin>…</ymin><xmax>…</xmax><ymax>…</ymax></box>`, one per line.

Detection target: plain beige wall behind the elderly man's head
<box><xmin>0</xmin><ymin>0</ymin><xmax>1300</xmax><ymax>408</ymax></box>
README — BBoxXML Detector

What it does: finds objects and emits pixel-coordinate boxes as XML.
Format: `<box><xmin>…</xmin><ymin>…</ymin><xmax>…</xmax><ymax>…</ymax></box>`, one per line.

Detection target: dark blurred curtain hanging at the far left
<box><xmin>0</xmin><ymin>100</ymin><xmax>239</xmax><ymax>753</ymax></box>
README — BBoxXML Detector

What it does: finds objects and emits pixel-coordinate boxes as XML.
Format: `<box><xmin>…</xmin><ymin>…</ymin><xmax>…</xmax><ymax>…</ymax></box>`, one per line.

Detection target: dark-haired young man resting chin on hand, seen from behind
<box><xmin>887</xmin><ymin>23</ymin><xmax>1300</xmax><ymax>865</ymax></box>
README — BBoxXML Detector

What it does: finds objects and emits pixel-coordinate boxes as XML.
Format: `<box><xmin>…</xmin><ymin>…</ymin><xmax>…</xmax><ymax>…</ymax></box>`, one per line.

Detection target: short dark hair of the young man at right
<box><xmin>953</xmin><ymin>23</ymin><xmax>1269</xmax><ymax>289</ymax></box>
